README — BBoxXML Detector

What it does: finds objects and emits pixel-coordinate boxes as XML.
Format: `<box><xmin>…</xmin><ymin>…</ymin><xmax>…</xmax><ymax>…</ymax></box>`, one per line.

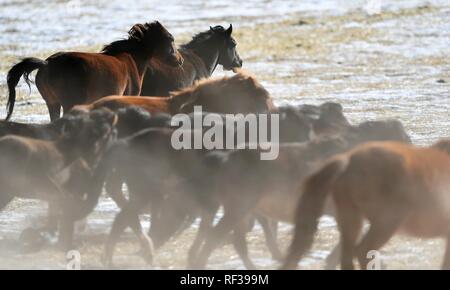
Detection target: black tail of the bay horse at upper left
<box><xmin>5</xmin><ymin>57</ymin><xmax>47</xmax><ymax>121</ymax></box>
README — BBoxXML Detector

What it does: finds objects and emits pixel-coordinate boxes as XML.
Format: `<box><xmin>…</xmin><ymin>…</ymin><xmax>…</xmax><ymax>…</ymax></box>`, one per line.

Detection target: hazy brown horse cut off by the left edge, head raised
<box><xmin>0</xmin><ymin>109</ymin><xmax>117</xmax><ymax>246</ymax></box>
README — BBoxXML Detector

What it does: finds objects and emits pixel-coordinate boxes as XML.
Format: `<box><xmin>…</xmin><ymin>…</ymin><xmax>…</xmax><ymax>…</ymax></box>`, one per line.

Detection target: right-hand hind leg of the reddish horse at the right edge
<box><xmin>357</xmin><ymin>215</ymin><xmax>403</xmax><ymax>270</ymax></box>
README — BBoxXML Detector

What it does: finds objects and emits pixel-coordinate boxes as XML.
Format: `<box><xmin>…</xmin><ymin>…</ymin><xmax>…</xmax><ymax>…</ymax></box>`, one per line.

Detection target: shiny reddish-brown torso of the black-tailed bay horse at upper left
<box><xmin>36</xmin><ymin>52</ymin><xmax>132</xmax><ymax>109</ymax></box>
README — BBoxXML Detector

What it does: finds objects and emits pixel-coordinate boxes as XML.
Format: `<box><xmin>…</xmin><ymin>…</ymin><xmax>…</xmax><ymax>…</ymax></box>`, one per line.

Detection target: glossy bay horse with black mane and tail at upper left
<box><xmin>6</xmin><ymin>22</ymin><xmax>182</xmax><ymax>121</ymax></box>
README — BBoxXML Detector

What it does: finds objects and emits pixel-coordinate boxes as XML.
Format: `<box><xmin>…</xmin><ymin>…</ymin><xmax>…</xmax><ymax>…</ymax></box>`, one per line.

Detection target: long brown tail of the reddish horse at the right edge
<box><xmin>282</xmin><ymin>158</ymin><xmax>348</xmax><ymax>270</ymax></box>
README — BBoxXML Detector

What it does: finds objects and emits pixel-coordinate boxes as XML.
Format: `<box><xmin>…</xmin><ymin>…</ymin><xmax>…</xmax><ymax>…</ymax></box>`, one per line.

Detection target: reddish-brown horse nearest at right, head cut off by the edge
<box><xmin>284</xmin><ymin>140</ymin><xmax>450</xmax><ymax>269</ymax></box>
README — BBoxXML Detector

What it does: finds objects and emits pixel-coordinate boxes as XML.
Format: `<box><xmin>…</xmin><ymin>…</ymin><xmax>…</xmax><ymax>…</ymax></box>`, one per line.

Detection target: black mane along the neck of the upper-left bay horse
<box><xmin>101</xmin><ymin>21</ymin><xmax>162</xmax><ymax>56</ymax></box>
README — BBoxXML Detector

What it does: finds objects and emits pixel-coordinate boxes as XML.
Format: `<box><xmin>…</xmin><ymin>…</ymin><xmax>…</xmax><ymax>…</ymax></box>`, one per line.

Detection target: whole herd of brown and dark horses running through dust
<box><xmin>0</xmin><ymin>22</ymin><xmax>450</xmax><ymax>269</ymax></box>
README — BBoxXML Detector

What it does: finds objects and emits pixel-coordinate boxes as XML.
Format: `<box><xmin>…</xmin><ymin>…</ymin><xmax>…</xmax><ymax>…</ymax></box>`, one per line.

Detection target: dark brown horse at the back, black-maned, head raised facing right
<box><xmin>141</xmin><ymin>25</ymin><xmax>242</xmax><ymax>96</ymax></box>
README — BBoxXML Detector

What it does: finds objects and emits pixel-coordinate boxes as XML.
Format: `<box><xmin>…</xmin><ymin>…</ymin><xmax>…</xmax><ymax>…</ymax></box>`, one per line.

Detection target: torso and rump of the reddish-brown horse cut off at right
<box><xmin>334</xmin><ymin>142</ymin><xmax>450</xmax><ymax>237</ymax></box>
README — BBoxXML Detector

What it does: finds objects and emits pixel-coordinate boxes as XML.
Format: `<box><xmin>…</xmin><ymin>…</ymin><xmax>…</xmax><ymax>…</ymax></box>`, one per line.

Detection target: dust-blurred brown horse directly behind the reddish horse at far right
<box><xmin>189</xmin><ymin>120</ymin><xmax>409</xmax><ymax>269</ymax></box>
